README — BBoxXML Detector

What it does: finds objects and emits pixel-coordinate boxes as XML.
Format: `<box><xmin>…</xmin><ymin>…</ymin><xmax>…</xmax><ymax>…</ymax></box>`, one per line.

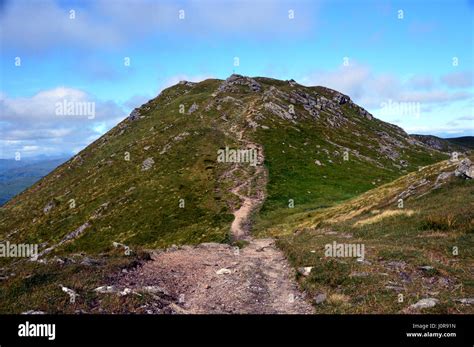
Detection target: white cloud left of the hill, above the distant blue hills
<box><xmin>0</xmin><ymin>87</ymin><xmax>126</xmax><ymax>158</ymax></box>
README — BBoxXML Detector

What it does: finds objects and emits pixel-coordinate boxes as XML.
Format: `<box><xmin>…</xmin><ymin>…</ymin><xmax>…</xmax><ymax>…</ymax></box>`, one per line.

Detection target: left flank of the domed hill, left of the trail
<box><xmin>0</xmin><ymin>81</ymin><xmax>237</xmax><ymax>252</ymax></box>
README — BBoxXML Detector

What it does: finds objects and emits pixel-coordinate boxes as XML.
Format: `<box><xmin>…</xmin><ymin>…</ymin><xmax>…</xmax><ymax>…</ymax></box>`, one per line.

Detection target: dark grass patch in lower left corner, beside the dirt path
<box><xmin>0</xmin><ymin>251</ymin><xmax>153</xmax><ymax>314</ymax></box>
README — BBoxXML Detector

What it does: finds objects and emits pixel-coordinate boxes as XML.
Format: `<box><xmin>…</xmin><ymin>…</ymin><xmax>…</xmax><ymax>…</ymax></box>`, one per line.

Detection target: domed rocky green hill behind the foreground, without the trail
<box><xmin>0</xmin><ymin>75</ymin><xmax>446</xmax><ymax>256</ymax></box>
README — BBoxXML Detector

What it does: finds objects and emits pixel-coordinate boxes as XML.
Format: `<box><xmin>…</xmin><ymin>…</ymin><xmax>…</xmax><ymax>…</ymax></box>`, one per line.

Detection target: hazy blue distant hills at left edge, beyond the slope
<box><xmin>0</xmin><ymin>158</ymin><xmax>67</xmax><ymax>206</ymax></box>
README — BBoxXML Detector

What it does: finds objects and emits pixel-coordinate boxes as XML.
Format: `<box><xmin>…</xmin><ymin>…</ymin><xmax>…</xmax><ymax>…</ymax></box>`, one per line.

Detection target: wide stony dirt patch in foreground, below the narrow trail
<box><xmin>116</xmin><ymin>239</ymin><xmax>312</xmax><ymax>314</ymax></box>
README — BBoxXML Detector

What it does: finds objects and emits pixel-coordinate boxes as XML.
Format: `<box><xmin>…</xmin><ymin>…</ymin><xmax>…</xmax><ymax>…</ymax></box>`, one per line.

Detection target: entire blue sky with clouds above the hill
<box><xmin>0</xmin><ymin>0</ymin><xmax>474</xmax><ymax>158</ymax></box>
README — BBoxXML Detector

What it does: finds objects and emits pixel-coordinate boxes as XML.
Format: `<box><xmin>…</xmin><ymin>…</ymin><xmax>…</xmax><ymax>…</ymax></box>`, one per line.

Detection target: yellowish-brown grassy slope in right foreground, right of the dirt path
<box><xmin>260</xmin><ymin>158</ymin><xmax>474</xmax><ymax>313</ymax></box>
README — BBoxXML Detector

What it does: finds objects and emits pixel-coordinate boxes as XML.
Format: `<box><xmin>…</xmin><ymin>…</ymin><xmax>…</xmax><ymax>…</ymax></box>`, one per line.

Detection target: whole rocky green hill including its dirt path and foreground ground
<box><xmin>0</xmin><ymin>75</ymin><xmax>472</xmax><ymax>314</ymax></box>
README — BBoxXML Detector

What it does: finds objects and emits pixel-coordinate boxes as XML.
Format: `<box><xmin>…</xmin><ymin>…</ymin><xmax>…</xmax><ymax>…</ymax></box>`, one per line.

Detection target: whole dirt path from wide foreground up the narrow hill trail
<box><xmin>110</xmin><ymin>102</ymin><xmax>313</xmax><ymax>314</ymax></box>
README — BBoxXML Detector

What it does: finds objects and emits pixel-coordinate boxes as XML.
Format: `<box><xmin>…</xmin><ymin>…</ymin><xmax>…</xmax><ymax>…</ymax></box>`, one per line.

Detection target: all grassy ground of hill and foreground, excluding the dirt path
<box><xmin>0</xmin><ymin>75</ymin><xmax>472</xmax><ymax>313</ymax></box>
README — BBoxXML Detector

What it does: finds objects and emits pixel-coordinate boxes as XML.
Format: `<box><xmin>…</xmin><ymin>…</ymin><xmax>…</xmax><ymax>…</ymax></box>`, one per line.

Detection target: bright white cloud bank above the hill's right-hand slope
<box><xmin>300</xmin><ymin>63</ymin><xmax>474</xmax><ymax>135</ymax></box>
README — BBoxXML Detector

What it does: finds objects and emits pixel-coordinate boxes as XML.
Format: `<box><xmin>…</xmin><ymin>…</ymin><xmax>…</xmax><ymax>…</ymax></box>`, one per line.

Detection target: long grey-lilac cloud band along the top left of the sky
<box><xmin>0</xmin><ymin>0</ymin><xmax>316</xmax><ymax>51</ymax></box>
